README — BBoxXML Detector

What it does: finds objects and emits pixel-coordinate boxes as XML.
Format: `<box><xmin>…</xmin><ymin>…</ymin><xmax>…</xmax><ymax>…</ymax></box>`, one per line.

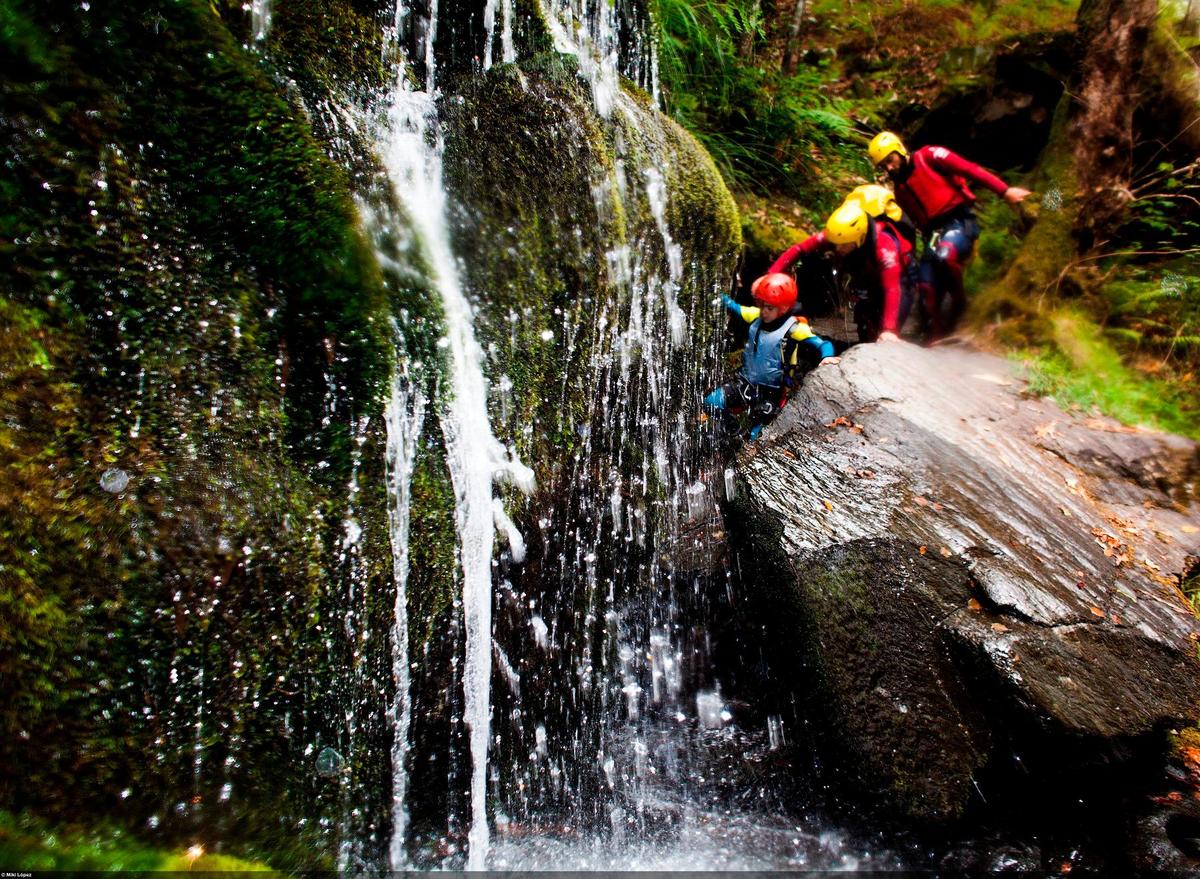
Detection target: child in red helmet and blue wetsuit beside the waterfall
<box><xmin>704</xmin><ymin>273</ymin><xmax>834</xmax><ymax>440</ymax></box>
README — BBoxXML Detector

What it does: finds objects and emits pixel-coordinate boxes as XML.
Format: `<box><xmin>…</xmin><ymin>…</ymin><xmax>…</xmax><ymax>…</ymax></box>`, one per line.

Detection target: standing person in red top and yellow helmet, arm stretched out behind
<box><xmin>866</xmin><ymin>131</ymin><xmax>1030</xmax><ymax>339</ymax></box>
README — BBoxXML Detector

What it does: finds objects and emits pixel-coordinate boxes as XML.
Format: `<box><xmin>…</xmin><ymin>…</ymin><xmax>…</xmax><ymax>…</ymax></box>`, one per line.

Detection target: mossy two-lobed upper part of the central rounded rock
<box><xmin>443</xmin><ymin>66</ymin><xmax>740</xmax><ymax>477</ymax></box>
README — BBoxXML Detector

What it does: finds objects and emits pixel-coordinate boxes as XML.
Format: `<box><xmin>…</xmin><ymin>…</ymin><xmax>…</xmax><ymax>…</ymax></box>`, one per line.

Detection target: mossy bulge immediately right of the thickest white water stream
<box><xmin>445</xmin><ymin>64</ymin><xmax>625</xmax><ymax>470</ymax></box>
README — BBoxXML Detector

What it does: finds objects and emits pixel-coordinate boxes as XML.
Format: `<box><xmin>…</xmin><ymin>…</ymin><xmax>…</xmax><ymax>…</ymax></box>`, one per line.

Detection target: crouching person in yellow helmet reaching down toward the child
<box><xmin>767</xmin><ymin>199</ymin><xmax>914</xmax><ymax>342</ymax></box>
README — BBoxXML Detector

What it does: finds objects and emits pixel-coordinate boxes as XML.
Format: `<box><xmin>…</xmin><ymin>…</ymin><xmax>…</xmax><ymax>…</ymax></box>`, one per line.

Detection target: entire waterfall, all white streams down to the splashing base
<box><xmin>364</xmin><ymin>0</ymin><xmax>902</xmax><ymax>869</ymax></box>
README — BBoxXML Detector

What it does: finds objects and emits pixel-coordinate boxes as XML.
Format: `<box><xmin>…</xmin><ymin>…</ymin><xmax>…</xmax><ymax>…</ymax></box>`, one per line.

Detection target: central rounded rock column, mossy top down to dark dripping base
<box><xmin>442</xmin><ymin>54</ymin><xmax>740</xmax><ymax>821</ymax></box>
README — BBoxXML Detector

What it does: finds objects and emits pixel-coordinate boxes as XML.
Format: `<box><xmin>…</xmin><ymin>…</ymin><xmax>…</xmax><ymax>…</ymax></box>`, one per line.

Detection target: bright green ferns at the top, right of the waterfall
<box><xmin>653</xmin><ymin>0</ymin><xmax>865</xmax><ymax>192</ymax></box>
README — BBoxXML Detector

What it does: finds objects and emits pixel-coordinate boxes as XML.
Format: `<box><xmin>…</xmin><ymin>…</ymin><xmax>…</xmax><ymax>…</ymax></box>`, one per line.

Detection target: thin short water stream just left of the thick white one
<box><xmin>386</xmin><ymin>345</ymin><xmax>426</xmax><ymax>872</ymax></box>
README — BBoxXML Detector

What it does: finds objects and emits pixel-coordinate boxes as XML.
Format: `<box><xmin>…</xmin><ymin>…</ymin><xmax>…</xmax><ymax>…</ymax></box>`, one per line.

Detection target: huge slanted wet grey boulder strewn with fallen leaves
<box><xmin>726</xmin><ymin>345</ymin><xmax>1200</xmax><ymax>821</ymax></box>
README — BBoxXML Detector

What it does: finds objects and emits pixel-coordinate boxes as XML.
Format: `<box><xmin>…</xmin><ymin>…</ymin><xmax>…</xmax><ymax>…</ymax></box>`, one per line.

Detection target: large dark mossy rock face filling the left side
<box><xmin>0</xmin><ymin>2</ymin><xmax>434</xmax><ymax>866</ymax></box>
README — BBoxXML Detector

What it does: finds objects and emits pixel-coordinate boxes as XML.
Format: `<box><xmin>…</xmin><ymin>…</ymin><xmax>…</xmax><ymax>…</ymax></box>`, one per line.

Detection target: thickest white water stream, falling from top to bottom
<box><xmin>379</xmin><ymin>4</ymin><xmax>533</xmax><ymax>869</ymax></box>
